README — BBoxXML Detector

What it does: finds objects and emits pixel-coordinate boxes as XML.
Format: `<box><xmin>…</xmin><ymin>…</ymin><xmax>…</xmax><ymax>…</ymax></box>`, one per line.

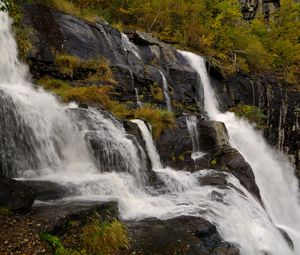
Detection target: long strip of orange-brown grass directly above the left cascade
<box><xmin>39</xmin><ymin>77</ymin><xmax>130</xmax><ymax>118</ymax></box>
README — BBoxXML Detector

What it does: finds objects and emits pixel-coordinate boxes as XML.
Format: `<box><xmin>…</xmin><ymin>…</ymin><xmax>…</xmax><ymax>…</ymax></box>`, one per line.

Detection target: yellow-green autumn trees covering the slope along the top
<box><xmin>39</xmin><ymin>0</ymin><xmax>300</xmax><ymax>82</ymax></box>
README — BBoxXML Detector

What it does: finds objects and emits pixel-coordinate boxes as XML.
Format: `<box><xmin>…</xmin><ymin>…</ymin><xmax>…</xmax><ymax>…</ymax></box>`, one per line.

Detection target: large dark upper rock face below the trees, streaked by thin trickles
<box><xmin>24</xmin><ymin>3</ymin><xmax>203</xmax><ymax>110</ymax></box>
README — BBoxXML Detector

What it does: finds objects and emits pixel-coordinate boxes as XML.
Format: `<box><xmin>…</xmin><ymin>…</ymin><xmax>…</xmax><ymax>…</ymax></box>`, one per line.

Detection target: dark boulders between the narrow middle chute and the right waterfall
<box><xmin>156</xmin><ymin>116</ymin><xmax>260</xmax><ymax>200</ymax></box>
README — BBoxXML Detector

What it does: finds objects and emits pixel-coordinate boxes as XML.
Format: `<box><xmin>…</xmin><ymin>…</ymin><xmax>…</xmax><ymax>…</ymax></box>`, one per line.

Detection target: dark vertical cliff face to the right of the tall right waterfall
<box><xmin>211</xmin><ymin>72</ymin><xmax>300</xmax><ymax>177</ymax></box>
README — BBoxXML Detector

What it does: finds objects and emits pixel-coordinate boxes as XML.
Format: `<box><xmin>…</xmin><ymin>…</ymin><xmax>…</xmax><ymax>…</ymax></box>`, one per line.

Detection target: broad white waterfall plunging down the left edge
<box><xmin>0</xmin><ymin>12</ymin><xmax>96</xmax><ymax>177</ymax></box>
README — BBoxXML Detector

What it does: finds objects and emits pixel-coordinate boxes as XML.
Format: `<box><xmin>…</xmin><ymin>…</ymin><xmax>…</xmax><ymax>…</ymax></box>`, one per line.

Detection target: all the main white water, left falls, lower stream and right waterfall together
<box><xmin>0</xmin><ymin>10</ymin><xmax>300</xmax><ymax>255</ymax></box>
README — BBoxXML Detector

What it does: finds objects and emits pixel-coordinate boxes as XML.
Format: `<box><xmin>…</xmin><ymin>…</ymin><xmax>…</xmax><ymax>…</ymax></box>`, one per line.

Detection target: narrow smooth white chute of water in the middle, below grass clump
<box><xmin>132</xmin><ymin>120</ymin><xmax>162</xmax><ymax>169</ymax></box>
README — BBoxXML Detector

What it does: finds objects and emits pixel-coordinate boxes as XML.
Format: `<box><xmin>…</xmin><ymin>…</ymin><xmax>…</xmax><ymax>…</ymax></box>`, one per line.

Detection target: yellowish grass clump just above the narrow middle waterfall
<box><xmin>134</xmin><ymin>104</ymin><xmax>175</xmax><ymax>139</ymax></box>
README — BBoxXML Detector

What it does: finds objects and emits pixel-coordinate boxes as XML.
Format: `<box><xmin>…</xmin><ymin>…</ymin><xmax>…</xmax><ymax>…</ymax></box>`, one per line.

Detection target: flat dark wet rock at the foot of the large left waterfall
<box><xmin>20</xmin><ymin>181</ymin><xmax>78</xmax><ymax>201</ymax></box>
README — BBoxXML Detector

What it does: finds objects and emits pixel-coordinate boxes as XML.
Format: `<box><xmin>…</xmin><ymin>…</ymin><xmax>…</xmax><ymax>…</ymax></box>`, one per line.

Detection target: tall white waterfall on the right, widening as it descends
<box><xmin>181</xmin><ymin>52</ymin><xmax>300</xmax><ymax>254</ymax></box>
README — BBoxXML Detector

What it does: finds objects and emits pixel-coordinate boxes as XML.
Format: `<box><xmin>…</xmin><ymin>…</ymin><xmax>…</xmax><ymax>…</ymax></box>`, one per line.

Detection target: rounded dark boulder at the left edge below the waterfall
<box><xmin>0</xmin><ymin>174</ymin><xmax>35</xmax><ymax>212</ymax></box>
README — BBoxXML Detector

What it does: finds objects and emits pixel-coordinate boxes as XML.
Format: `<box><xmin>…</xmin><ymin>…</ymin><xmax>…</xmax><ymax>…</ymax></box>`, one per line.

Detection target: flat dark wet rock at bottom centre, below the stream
<box><xmin>125</xmin><ymin>216</ymin><xmax>240</xmax><ymax>255</ymax></box>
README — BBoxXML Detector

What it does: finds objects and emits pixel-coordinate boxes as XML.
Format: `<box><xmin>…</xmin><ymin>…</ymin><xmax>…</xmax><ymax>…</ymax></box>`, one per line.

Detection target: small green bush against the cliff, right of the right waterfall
<box><xmin>230</xmin><ymin>104</ymin><xmax>266</xmax><ymax>129</ymax></box>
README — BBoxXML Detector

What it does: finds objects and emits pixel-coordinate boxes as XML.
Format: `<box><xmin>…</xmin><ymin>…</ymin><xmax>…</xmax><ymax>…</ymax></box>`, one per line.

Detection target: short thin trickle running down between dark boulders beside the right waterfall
<box><xmin>186</xmin><ymin>116</ymin><xmax>205</xmax><ymax>160</ymax></box>
